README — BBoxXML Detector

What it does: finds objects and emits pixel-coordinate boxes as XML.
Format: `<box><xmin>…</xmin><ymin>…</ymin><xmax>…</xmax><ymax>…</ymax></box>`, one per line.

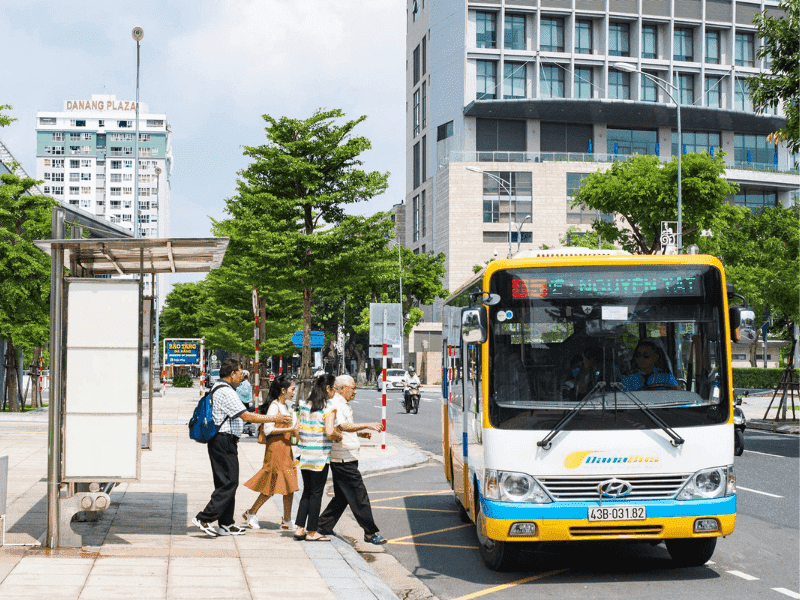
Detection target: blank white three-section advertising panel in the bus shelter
<box><xmin>64</xmin><ymin>279</ymin><xmax>140</xmax><ymax>481</ymax></box>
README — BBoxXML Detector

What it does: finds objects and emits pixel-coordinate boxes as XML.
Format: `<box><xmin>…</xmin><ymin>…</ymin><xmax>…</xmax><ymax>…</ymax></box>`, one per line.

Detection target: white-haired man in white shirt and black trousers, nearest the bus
<box><xmin>317</xmin><ymin>375</ymin><xmax>386</xmax><ymax>544</ymax></box>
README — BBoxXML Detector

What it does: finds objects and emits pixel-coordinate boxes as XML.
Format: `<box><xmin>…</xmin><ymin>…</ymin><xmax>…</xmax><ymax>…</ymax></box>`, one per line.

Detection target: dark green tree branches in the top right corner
<box><xmin>747</xmin><ymin>0</ymin><xmax>800</xmax><ymax>152</ymax></box>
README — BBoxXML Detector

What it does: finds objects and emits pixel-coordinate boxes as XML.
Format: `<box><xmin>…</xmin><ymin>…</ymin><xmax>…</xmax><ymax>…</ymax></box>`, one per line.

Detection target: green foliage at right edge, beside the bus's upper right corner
<box><xmin>699</xmin><ymin>206</ymin><xmax>800</xmax><ymax>323</ymax></box>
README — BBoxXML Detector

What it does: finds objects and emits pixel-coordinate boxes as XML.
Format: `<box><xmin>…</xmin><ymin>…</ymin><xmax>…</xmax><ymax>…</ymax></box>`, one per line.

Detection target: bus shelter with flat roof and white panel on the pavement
<box><xmin>35</xmin><ymin>208</ymin><xmax>228</xmax><ymax>548</ymax></box>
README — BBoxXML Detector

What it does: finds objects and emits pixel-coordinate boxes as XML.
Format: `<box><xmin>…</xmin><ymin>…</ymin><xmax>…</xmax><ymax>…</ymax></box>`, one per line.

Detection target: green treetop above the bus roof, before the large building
<box><xmin>572</xmin><ymin>152</ymin><xmax>738</xmax><ymax>254</ymax></box>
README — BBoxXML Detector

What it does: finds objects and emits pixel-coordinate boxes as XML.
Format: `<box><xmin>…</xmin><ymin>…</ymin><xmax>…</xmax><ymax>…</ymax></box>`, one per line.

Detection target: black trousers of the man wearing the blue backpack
<box><xmin>197</xmin><ymin>433</ymin><xmax>239</xmax><ymax>525</ymax></box>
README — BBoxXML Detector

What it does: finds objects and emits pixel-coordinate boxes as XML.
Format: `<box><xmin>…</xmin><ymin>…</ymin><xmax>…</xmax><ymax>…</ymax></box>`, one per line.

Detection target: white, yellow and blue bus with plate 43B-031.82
<box><xmin>442</xmin><ymin>249</ymin><xmax>755</xmax><ymax>570</ymax></box>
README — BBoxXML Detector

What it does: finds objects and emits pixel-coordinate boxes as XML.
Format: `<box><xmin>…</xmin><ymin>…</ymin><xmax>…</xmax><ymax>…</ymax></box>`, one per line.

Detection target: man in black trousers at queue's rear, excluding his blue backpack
<box><xmin>192</xmin><ymin>359</ymin><xmax>292</xmax><ymax>537</ymax></box>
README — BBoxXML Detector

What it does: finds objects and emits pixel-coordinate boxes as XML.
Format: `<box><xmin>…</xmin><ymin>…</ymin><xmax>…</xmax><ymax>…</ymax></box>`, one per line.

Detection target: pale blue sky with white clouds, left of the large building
<box><xmin>0</xmin><ymin>0</ymin><xmax>406</xmax><ymax>283</ymax></box>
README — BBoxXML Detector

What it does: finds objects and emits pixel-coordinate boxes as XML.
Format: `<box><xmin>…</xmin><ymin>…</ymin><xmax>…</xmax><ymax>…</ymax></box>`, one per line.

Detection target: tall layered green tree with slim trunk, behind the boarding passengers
<box><xmin>215</xmin><ymin>110</ymin><xmax>388</xmax><ymax>390</ymax></box>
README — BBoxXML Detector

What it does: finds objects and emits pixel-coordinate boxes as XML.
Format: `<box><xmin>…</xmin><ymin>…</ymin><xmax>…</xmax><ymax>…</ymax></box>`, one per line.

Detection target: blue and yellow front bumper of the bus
<box><xmin>481</xmin><ymin>496</ymin><xmax>736</xmax><ymax>542</ymax></box>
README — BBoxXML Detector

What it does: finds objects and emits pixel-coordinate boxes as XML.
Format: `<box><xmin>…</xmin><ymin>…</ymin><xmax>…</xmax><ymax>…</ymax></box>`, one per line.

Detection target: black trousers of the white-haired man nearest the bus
<box><xmin>319</xmin><ymin>460</ymin><xmax>378</xmax><ymax>536</ymax></box>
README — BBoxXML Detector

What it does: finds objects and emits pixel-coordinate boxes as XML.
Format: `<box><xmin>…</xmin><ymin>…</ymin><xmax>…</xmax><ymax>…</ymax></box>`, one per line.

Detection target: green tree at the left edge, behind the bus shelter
<box><xmin>0</xmin><ymin>171</ymin><xmax>57</xmax><ymax>410</ymax></box>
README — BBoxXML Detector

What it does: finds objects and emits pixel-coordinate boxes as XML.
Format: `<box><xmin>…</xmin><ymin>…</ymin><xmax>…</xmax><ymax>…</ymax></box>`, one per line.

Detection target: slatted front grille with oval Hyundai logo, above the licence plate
<box><xmin>536</xmin><ymin>473</ymin><xmax>692</xmax><ymax>502</ymax></box>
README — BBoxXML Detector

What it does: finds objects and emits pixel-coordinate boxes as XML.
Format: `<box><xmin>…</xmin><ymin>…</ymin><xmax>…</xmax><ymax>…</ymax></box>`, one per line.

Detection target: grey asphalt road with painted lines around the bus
<box><xmin>353</xmin><ymin>389</ymin><xmax>800</xmax><ymax>600</ymax></box>
